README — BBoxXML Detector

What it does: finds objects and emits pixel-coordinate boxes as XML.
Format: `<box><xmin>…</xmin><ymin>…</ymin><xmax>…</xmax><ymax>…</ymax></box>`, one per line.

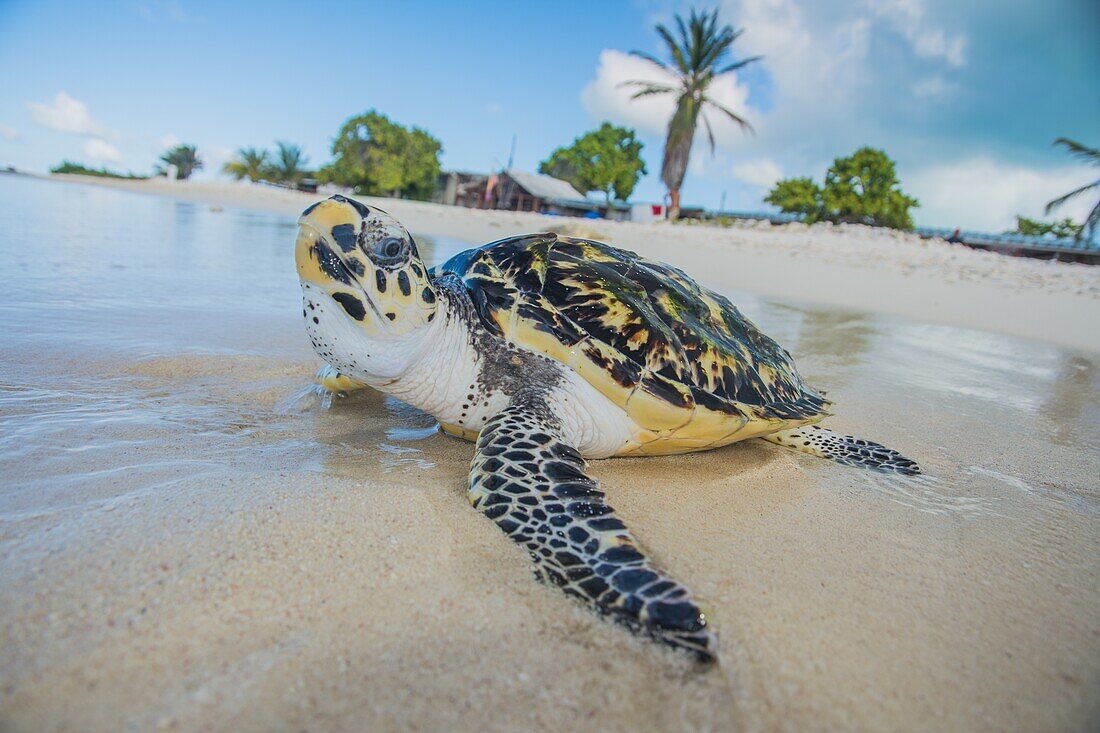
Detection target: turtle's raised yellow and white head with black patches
<box><xmin>295</xmin><ymin>196</ymin><xmax>437</xmax><ymax>375</ymax></box>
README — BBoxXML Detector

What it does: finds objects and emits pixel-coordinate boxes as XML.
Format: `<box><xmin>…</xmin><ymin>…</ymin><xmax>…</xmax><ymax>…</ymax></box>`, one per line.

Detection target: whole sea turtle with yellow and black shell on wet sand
<box><xmin>296</xmin><ymin>196</ymin><xmax>920</xmax><ymax>659</ymax></box>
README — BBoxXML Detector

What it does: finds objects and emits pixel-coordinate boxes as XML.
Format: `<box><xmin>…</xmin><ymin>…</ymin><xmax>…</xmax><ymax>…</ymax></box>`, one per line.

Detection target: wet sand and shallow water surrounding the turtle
<box><xmin>0</xmin><ymin>177</ymin><xmax>1100</xmax><ymax>731</ymax></box>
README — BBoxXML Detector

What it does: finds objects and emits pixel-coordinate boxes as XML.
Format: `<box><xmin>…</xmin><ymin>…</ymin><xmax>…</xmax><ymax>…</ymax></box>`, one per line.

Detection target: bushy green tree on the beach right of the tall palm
<box><xmin>763</xmin><ymin>147</ymin><xmax>920</xmax><ymax>229</ymax></box>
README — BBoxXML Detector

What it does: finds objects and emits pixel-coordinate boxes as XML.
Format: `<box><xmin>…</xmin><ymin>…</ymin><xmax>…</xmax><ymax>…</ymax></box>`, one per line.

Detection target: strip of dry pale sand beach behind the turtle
<box><xmin>47</xmin><ymin>175</ymin><xmax>1100</xmax><ymax>352</ymax></box>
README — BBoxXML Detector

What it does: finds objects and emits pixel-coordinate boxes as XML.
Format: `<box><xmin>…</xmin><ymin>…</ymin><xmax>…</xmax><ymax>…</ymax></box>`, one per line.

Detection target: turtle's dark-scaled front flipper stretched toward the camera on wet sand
<box><xmin>470</xmin><ymin>396</ymin><xmax>715</xmax><ymax>660</ymax></box>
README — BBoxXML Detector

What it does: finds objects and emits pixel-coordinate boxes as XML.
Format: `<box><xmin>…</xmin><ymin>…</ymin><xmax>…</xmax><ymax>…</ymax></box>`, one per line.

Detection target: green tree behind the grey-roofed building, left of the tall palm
<box><xmin>539</xmin><ymin>122</ymin><xmax>646</xmax><ymax>201</ymax></box>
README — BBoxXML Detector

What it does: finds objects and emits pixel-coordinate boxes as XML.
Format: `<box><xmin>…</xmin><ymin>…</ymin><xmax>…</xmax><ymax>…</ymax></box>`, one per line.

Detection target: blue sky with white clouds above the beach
<box><xmin>0</xmin><ymin>0</ymin><xmax>1100</xmax><ymax>229</ymax></box>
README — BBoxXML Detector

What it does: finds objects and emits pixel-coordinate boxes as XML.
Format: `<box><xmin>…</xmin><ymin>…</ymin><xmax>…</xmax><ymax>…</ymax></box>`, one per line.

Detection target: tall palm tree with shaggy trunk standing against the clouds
<box><xmin>622</xmin><ymin>10</ymin><xmax>760</xmax><ymax>219</ymax></box>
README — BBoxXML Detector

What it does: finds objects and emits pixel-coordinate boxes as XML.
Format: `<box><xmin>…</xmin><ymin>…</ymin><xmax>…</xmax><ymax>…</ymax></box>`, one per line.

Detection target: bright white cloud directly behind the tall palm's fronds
<box><xmin>581</xmin><ymin>51</ymin><xmax>757</xmax><ymax>147</ymax></box>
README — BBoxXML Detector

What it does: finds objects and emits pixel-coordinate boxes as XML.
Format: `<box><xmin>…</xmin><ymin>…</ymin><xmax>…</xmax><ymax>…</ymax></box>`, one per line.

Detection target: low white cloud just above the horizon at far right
<box><xmin>901</xmin><ymin>157</ymin><xmax>1096</xmax><ymax>231</ymax></box>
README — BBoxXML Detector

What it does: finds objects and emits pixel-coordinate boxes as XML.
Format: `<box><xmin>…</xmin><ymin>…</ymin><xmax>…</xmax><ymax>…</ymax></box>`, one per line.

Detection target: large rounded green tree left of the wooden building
<box><xmin>318</xmin><ymin>110</ymin><xmax>443</xmax><ymax>199</ymax></box>
